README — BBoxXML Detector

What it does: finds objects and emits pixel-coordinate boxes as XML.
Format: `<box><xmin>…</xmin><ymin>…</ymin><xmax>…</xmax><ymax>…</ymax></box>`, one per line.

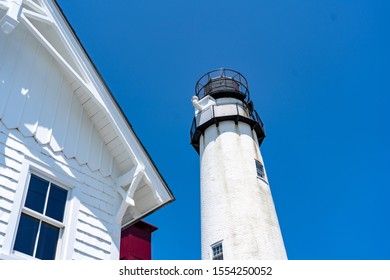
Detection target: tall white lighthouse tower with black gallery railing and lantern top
<box><xmin>190</xmin><ymin>69</ymin><xmax>287</xmax><ymax>260</ymax></box>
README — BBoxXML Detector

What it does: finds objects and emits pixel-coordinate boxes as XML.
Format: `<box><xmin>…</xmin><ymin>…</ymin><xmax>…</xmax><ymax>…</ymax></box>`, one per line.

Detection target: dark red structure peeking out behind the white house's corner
<box><xmin>119</xmin><ymin>221</ymin><xmax>157</xmax><ymax>260</ymax></box>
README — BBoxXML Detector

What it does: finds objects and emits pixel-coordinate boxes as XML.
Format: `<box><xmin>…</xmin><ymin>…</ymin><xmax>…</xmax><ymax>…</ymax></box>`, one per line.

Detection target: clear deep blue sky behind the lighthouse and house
<box><xmin>58</xmin><ymin>0</ymin><xmax>390</xmax><ymax>259</ymax></box>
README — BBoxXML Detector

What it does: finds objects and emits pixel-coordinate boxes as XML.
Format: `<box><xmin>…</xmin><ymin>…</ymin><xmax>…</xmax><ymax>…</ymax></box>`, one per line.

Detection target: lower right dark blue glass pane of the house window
<box><xmin>35</xmin><ymin>222</ymin><xmax>60</xmax><ymax>260</ymax></box>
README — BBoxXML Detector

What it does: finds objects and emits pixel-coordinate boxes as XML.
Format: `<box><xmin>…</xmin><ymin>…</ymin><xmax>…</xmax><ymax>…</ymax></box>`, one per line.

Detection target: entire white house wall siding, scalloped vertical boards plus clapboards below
<box><xmin>0</xmin><ymin>25</ymin><xmax>121</xmax><ymax>259</ymax></box>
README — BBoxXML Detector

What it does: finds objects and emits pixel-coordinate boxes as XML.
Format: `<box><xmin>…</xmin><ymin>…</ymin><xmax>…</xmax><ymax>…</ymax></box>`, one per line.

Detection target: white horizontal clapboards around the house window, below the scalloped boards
<box><xmin>0</xmin><ymin>123</ymin><xmax>119</xmax><ymax>259</ymax></box>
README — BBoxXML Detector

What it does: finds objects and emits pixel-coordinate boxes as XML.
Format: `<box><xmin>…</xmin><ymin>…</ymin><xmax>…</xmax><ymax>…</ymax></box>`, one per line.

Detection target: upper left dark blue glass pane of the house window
<box><xmin>25</xmin><ymin>174</ymin><xmax>49</xmax><ymax>213</ymax></box>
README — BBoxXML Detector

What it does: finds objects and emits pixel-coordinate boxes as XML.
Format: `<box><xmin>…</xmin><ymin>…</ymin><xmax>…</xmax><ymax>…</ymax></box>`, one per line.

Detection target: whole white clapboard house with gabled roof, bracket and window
<box><xmin>0</xmin><ymin>0</ymin><xmax>174</xmax><ymax>259</ymax></box>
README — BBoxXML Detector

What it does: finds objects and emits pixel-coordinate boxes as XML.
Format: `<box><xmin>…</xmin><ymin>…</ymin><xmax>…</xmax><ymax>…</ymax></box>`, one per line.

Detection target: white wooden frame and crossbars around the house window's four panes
<box><xmin>11</xmin><ymin>173</ymin><xmax>71</xmax><ymax>260</ymax></box>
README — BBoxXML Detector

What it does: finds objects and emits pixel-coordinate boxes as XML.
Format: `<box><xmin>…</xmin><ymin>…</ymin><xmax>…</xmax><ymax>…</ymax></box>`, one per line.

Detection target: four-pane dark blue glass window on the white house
<box><xmin>14</xmin><ymin>174</ymin><xmax>68</xmax><ymax>260</ymax></box>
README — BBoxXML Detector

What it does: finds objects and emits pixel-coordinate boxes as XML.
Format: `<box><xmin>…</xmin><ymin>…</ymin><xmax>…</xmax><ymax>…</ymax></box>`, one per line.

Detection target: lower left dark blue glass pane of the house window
<box><xmin>14</xmin><ymin>214</ymin><xmax>39</xmax><ymax>256</ymax></box>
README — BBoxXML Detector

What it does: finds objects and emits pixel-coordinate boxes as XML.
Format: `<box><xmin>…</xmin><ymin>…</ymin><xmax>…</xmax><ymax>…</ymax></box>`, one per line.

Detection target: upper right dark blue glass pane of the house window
<box><xmin>46</xmin><ymin>184</ymin><xmax>68</xmax><ymax>222</ymax></box>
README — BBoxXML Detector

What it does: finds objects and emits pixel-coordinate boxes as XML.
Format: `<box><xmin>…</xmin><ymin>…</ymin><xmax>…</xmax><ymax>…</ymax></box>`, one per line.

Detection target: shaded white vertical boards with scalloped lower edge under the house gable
<box><xmin>0</xmin><ymin>26</ymin><xmax>123</xmax><ymax>176</ymax></box>
